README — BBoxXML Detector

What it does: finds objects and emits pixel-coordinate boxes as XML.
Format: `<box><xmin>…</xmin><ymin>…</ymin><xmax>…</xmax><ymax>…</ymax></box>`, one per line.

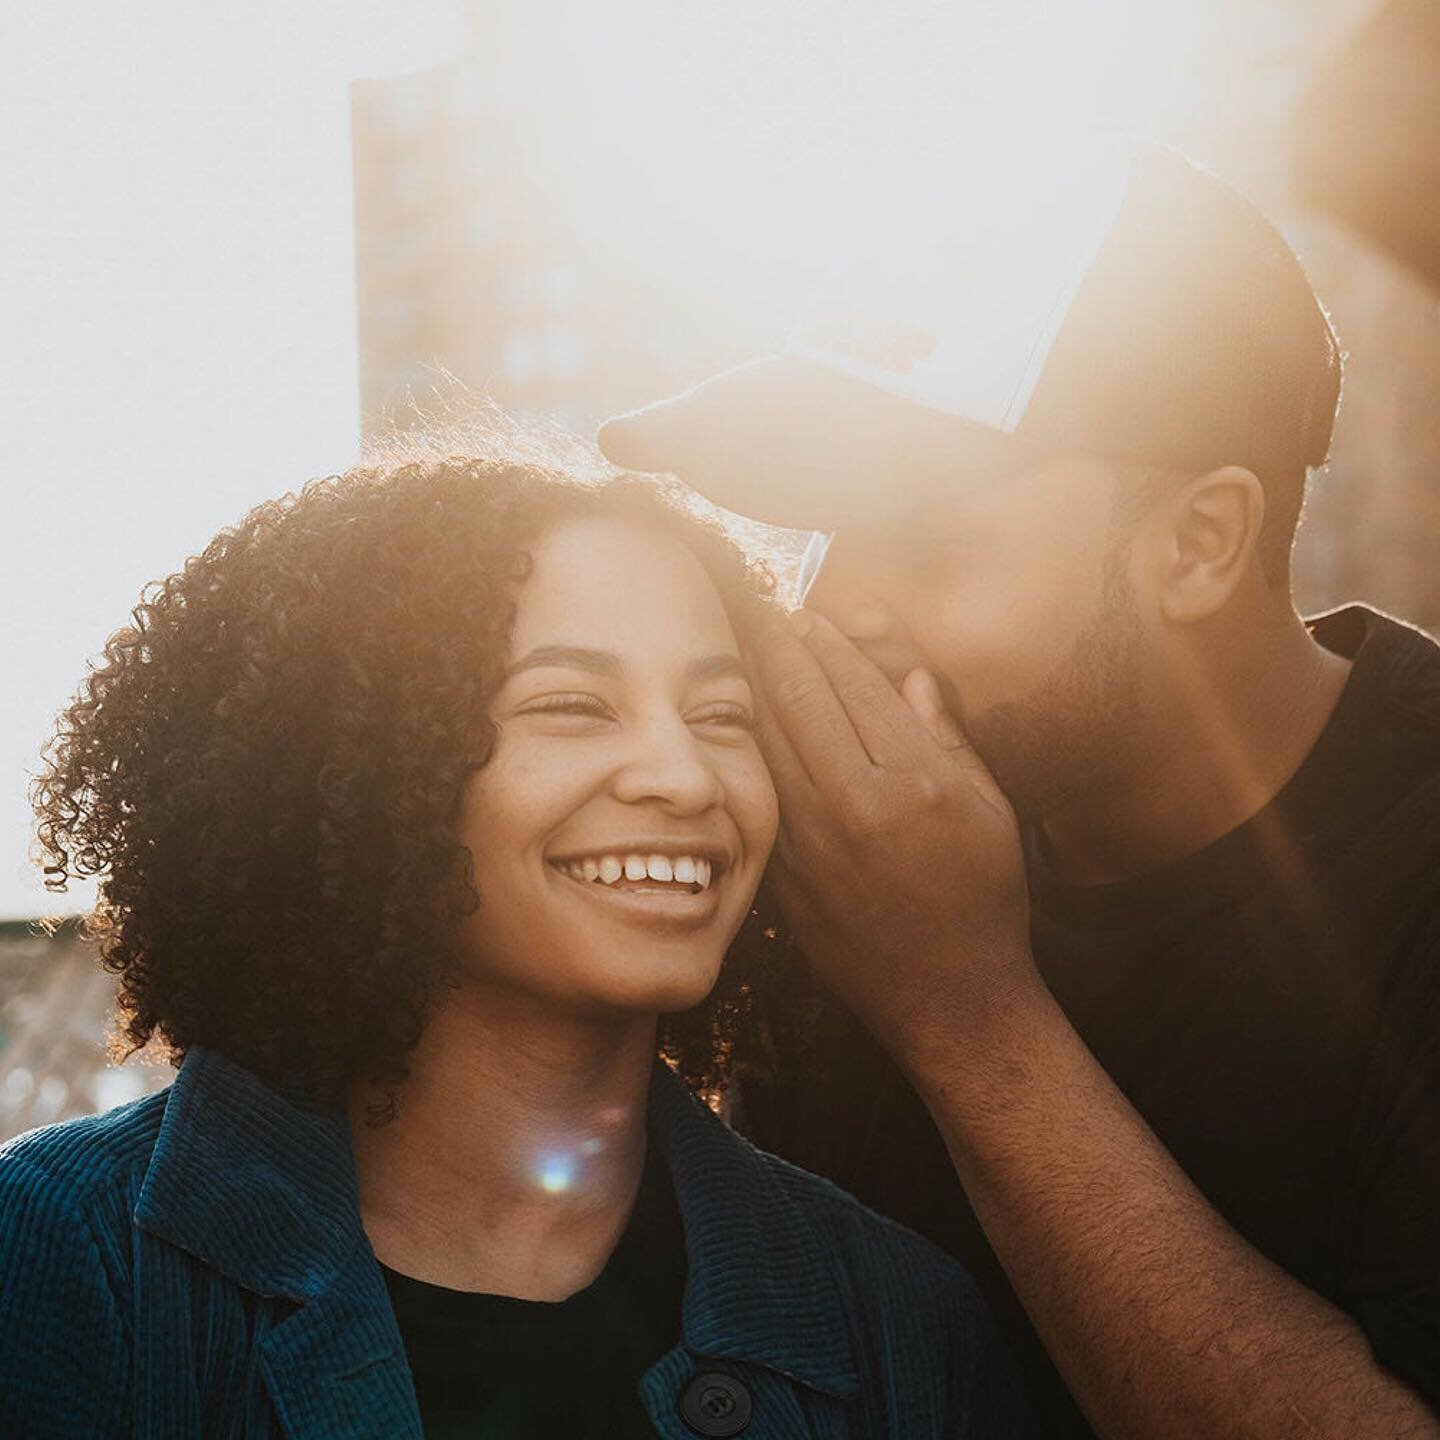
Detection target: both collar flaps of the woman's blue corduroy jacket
<box><xmin>135</xmin><ymin>1047</ymin><xmax>860</xmax><ymax>1398</ymax></box>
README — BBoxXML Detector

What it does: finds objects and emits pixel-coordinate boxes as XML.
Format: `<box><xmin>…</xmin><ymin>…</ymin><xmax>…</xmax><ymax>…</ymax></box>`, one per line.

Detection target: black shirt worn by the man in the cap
<box><xmin>739</xmin><ymin>606</ymin><xmax>1440</xmax><ymax>1437</ymax></box>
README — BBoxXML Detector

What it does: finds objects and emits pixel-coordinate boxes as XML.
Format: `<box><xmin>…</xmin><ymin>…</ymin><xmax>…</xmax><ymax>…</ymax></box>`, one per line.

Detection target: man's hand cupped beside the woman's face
<box><xmin>757</xmin><ymin>612</ymin><xmax>1043</xmax><ymax>1066</ymax></box>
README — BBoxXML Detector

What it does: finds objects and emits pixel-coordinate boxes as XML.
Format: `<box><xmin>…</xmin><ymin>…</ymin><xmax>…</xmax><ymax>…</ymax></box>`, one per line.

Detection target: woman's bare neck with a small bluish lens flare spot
<box><xmin>350</xmin><ymin>978</ymin><xmax>655</xmax><ymax>1300</ymax></box>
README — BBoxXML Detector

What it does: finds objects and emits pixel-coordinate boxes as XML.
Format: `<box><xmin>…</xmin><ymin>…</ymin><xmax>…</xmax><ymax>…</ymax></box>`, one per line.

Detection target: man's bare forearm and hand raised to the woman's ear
<box><xmin>759</xmin><ymin>619</ymin><xmax>1440</xmax><ymax>1440</ymax></box>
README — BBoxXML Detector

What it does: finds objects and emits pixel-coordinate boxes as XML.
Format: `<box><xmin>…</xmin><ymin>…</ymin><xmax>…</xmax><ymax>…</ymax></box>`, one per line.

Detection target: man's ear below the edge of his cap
<box><xmin>1156</xmin><ymin>465</ymin><xmax>1264</xmax><ymax>624</ymax></box>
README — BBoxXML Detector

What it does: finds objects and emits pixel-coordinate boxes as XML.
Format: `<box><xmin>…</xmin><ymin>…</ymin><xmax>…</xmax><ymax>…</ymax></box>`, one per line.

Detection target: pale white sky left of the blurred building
<box><xmin>0</xmin><ymin>0</ymin><xmax>461</xmax><ymax>919</ymax></box>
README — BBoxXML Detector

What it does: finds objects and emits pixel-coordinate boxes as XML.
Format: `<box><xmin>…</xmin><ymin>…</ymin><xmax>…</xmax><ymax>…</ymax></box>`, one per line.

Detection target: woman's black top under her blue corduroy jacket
<box><xmin>382</xmin><ymin>1146</ymin><xmax>685</xmax><ymax>1440</ymax></box>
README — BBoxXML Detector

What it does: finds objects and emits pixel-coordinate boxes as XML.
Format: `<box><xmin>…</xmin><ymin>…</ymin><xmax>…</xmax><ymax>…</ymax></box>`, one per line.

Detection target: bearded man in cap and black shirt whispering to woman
<box><xmin>600</xmin><ymin>147</ymin><xmax>1440</xmax><ymax>1440</ymax></box>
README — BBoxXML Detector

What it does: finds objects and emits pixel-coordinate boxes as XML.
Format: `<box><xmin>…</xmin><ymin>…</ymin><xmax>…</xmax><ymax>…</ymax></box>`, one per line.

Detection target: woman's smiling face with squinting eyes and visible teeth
<box><xmin>459</xmin><ymin>517</ymin><xmax>776</xmax><ymax>1014</ymax></box>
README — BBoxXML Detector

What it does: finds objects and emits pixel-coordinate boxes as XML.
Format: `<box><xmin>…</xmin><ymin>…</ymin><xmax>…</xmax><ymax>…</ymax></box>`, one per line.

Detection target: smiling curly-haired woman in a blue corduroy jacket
<box><xmin>0</xmin><ymin>459</ymin><xmax>1025</xmax><ymax>1440</ymax></box>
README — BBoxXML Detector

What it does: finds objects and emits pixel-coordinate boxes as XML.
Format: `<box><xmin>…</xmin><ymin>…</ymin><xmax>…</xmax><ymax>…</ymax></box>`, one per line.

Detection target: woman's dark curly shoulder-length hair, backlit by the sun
<box><xmin>33</xmin><ymin>458</ymin><xmax>806</xmax><ymax>1106</ymax></box>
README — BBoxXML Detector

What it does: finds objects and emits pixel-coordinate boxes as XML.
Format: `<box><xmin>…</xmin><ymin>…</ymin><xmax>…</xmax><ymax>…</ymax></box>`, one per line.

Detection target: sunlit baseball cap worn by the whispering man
<box><xmin>599</xmin><ymin>141</ymin><xmax>1341</xmax><ymax>528</ymax></box>
